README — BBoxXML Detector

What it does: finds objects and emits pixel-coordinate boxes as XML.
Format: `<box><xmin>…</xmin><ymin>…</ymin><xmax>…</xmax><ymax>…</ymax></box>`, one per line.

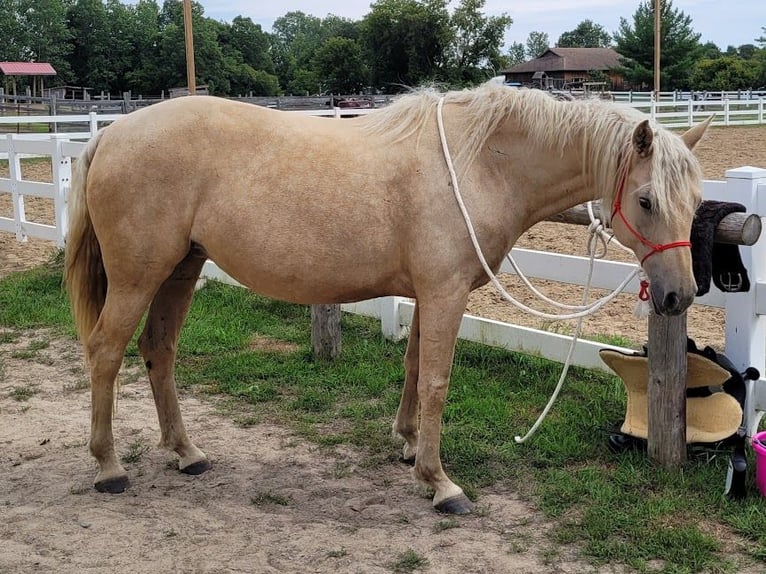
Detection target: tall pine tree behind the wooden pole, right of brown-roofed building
<box><xmin>614</xmin><ymin>0</ymin><xmax>704</xmax><ymax>90</ymax></box>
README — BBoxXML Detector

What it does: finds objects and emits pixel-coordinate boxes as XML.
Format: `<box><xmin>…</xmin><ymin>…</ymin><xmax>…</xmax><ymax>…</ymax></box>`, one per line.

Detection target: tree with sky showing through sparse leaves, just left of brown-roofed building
<box><xmin>443</xmin><ymin>0</ymin><xmax>513</xmax><ymax>85</ymax></box>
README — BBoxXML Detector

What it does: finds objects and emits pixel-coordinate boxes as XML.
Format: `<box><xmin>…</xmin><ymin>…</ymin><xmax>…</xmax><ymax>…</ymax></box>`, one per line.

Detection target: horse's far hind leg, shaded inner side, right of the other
<box><xmin>138</xmin><ymin>249</ymin><xmax>210</xmax><ymax>474</ymax></box>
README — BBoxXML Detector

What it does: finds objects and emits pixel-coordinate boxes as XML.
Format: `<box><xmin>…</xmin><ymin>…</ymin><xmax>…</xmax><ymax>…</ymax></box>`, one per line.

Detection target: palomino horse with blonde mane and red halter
<box><xmin>65</xmin><ymin>85</ymin><xmax>706</xmax><ymax>513</ymax></box>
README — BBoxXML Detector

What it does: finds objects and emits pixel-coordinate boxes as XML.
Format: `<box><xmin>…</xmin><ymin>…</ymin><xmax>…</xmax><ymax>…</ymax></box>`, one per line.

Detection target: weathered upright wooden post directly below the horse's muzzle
<box><xmin>647</xmin><ymin>313</ymin><xmax>686</xmax><ymax>468</ymax></box>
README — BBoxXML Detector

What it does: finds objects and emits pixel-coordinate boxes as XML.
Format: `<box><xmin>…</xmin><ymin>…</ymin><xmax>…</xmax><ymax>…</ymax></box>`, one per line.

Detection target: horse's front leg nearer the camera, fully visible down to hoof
<box><xmin>413</xmin><ymin>290</ymin><xmax>473</xmax><ymax>514</ymax></box>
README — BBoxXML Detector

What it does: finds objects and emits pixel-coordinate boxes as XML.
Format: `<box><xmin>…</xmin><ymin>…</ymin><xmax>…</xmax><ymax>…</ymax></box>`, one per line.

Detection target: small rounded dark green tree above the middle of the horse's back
<box><xmin>313</xmin><ymin>36</ymin><xmax>369</xmax><ymax>94</ymax></box>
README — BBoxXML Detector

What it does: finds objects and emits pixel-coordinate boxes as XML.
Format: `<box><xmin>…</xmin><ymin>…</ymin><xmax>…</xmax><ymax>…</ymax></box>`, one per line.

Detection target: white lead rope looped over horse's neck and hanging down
<box><xmin>436</xmin><ymin>97</ymin><xmax>639</xmax><ymax>444</ymax></box>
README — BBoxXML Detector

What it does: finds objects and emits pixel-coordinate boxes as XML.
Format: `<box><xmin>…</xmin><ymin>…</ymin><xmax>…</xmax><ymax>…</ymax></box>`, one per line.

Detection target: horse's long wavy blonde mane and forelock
<box><xmin>360</xmin><ymin>84</ymin><xmax>702</xmax><ymax>224</ymax></box>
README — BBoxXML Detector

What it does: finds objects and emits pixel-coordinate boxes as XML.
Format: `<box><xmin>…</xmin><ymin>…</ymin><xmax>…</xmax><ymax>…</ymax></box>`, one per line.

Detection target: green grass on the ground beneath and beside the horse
<box><xmin>0</xmin><ymin>265</ymin><xmax>766</xmax><ymax>574</ymax></box>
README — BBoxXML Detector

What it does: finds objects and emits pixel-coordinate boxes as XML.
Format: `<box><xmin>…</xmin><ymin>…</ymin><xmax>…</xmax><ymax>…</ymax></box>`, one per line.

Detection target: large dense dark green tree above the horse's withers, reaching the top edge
<box><xmin>361</xmin><ymin>0</ymin><xmax>453</xmax><ymax>92</ymax></box>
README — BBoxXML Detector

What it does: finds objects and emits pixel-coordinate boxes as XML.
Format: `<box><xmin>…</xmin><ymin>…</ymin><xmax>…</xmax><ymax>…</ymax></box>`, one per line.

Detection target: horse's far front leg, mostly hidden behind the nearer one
<box><xmin>394</xmin><ymin>301</ymin><xmax>420</xmax><ymax>464</ymax></box>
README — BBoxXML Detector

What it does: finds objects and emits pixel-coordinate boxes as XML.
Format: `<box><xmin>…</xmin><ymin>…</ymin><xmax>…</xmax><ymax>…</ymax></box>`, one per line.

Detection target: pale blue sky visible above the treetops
<box><xmin>196</xmin><ymin>0</ymin><xmax>766</xmax><ymax>50</ymax></box>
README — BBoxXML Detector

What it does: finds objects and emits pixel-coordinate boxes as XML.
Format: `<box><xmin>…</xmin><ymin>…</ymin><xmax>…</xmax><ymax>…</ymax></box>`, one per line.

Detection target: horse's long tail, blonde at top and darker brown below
<box><xmin>64</xmin><ymin>131</ymin><xmax>107</xmax><ymax>360</ymax></box>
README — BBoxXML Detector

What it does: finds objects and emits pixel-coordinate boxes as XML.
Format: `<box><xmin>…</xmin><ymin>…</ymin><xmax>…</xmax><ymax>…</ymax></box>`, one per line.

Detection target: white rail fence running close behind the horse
<box><xmin>0</xmin><ymin>124</ymin><xmax>766</xmax><ymax>440</ymax></box>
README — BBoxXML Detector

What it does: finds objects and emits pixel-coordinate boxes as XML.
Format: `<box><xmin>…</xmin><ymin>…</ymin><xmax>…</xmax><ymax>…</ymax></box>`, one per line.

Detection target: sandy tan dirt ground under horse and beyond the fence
<box><xmin>0</xmin><ymin>127</ymin><xmax>766</xmax><ymax>574</ymax></box>
